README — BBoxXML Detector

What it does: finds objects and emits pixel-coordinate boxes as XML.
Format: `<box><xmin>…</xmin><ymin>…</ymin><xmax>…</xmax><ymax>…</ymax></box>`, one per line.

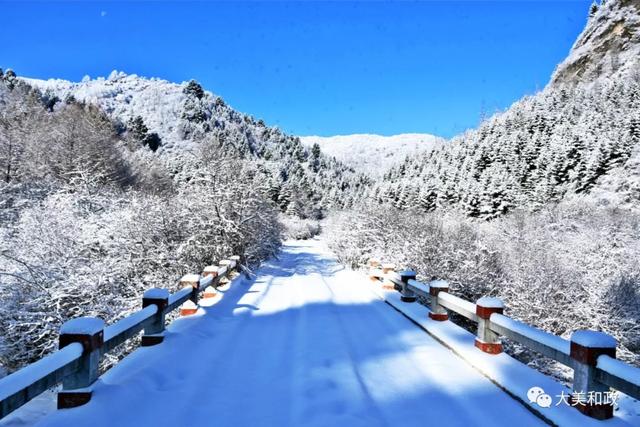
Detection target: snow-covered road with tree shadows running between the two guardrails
<box><xmin>32</xmin><ymin>241</ymin><xmax>543</xmax><ymax>427</ymax></box>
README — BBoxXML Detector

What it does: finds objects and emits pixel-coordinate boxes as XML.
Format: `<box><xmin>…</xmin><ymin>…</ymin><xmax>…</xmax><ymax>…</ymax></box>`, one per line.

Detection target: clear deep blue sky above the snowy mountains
<box><xmin>0</xmin><ymin>0</ymin><xmax>591</xmax><ymax>137</ymax></box>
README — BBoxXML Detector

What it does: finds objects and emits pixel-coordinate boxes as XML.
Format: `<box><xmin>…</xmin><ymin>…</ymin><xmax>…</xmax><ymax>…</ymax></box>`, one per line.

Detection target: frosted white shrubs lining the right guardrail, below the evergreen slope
<box><xmin>325</xmin><ymin>200</ymin><xmax>640</xmax><ymax>370</ymax></box>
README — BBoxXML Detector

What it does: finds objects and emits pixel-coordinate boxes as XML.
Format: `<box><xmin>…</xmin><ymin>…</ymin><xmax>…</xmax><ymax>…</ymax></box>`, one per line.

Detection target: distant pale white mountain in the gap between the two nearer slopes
<box><xmin>300</xmin><ymin>133</ymin><xmax>444</xmax><ymax>176</ymax></box>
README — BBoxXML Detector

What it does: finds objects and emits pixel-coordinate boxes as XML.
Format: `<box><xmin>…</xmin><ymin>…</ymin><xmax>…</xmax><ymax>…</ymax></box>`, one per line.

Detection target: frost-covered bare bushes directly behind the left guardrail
<box><xmin>0</xmin><ymin>160</ymin><xmax>280</xmax><ymax>369</ymax></box>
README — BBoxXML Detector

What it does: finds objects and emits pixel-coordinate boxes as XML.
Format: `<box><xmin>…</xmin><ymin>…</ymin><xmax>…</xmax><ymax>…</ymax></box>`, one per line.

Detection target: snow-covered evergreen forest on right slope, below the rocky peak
<box><xmin>371</xmin><ymin>70</ymin><xmax>640</xmax><ymax>219</ymax></box>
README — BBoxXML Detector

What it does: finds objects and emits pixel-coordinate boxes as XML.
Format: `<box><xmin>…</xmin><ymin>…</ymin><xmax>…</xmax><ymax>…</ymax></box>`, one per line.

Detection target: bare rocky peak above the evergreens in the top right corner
<box><xmin>551</xmin><ymin>0</ymin><xmax>640</xmax><ymax>85</ymax></box>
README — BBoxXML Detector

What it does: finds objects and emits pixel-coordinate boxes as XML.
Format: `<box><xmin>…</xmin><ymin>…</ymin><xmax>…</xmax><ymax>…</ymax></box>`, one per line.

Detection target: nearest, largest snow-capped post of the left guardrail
<box><xmin>58</xmin><ymin>317</ymin><xmax>104</xmax><ymax>409</ymax></box>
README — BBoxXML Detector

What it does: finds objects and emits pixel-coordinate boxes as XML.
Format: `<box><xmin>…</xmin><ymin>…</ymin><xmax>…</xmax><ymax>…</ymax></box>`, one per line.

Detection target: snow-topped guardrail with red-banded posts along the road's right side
<box><xmin>369</xmin><ymin>260</ymin><xmax>640</xmax><ymax>419</ymax></box>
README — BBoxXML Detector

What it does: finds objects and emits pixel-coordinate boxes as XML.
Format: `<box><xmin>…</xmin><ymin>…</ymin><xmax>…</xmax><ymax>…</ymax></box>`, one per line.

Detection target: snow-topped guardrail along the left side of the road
<box><xmin>0</xmin><ymin>256</ymin><xmax>240</xmax><ymax>418</ymax></box>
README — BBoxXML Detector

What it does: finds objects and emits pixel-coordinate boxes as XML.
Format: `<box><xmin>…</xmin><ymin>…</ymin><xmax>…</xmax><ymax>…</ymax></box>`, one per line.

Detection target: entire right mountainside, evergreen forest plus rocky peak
<box><xmin>371</xmin><ymin>0</ymin><xmax>640</xmax><ymax>218</ymax></box>
